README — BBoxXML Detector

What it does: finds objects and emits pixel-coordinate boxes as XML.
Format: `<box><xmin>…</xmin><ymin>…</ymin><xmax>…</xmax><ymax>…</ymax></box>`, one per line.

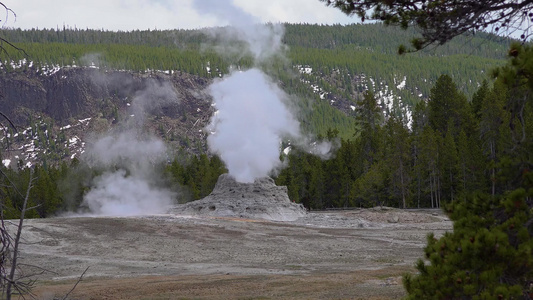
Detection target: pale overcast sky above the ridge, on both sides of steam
<box><xmin>0</xmin><ymin>0</ymin><xmax>358</xmax><ymax>31</ymax></box>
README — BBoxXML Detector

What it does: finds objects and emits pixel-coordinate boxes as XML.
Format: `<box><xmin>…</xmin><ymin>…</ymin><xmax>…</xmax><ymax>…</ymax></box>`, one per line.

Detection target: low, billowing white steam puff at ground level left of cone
<box><xmin>83</xmin><ymin>131</ymin><xmax>175</xmax><ymax>216</ymax></box>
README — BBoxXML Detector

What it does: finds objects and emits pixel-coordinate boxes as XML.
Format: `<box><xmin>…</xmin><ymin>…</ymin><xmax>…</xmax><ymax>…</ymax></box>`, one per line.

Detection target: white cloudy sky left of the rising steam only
<box><xmin>4</xmin><ymin>0</ymin><xmax>214</xmax><ymax>31</ymax></box>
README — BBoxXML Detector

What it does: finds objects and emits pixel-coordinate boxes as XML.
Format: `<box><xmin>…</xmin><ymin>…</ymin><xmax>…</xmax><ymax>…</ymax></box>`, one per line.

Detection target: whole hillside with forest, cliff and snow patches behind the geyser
<box><xmin>0</xmin><ymin>24</ymin><xmax>509</xmax><ymax>168</ymax></box>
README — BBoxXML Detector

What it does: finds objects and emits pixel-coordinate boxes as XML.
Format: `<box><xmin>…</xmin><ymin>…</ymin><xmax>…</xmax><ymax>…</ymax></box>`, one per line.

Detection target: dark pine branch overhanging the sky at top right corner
<box><xmin>320</xmin><ymin>0</ymin><xmax>533</xmax><ymax>53</ymax></box>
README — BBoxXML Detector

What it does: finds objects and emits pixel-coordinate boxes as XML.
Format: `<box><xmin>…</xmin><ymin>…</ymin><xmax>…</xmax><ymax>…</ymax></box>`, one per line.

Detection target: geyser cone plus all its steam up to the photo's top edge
<box><xmin>171</xmin><ymin>0</ymin><xmax>331</xmax><ymax>221</ymax></box>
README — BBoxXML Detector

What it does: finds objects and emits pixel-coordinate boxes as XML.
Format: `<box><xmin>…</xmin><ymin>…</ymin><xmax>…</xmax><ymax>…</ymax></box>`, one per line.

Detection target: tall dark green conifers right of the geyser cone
<box><xmin>277</xmin><ymin>67</ymin><xmax>533</xmax><ymax>209</ymax></box>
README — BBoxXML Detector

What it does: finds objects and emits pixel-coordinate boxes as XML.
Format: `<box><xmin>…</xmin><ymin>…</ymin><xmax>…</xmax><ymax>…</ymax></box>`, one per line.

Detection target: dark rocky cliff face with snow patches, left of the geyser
<box><xmin>0</xmin><ymin>68</ymin><xmax>213</xmax><ymax>168</ymax></box>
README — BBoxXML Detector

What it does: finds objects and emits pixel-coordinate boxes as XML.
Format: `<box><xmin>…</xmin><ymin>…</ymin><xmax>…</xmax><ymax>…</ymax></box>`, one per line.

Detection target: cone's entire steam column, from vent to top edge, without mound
<box><xmin>195</xmin><ymin>0</ymin><xmax>332</xmax><ymax>183</ymax></box>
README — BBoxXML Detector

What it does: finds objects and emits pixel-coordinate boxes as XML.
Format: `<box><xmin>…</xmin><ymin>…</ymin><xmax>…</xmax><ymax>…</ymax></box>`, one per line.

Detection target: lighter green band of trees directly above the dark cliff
<box><xmin>3</xmin><ymin>43</ymin><xmax>237</xmax><ymax>78</ymax></box>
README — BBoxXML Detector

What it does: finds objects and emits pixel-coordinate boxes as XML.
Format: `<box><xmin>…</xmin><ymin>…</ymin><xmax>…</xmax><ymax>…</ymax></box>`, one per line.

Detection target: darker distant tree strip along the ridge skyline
<box><xmin>0</xmin><ymin>23</ymin><xmax>510</xmax><ymax>59</ymax></box>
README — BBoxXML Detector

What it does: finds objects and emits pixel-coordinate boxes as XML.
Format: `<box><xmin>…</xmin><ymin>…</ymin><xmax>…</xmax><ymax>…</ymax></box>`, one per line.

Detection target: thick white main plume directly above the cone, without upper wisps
<box><xmin>207</xmin><ymin>69</ymin><xmax>299</xmax><ymax>182</ymax></box>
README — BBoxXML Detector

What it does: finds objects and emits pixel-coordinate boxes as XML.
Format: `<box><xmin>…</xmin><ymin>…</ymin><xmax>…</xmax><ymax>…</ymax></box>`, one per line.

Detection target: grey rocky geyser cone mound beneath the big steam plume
<box><xmin>170</xmin><ymin>174</ymin><xmax>306</xmax><ymax>221</ymax></box>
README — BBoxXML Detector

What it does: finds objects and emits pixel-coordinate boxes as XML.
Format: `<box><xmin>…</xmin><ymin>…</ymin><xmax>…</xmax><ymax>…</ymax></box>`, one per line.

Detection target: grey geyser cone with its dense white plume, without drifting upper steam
<box><xmin>172</xmin><ymin>69</ymin><xmax>306</xmax><ymax>221</ymax></box>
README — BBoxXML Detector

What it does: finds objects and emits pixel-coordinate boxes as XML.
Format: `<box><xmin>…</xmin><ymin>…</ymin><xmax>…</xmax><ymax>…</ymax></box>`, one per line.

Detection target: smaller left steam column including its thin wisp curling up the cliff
<box><xmin>82</xmin><ymin>80</ymin><xmax>178</xmax><ymax>216</ymax></box>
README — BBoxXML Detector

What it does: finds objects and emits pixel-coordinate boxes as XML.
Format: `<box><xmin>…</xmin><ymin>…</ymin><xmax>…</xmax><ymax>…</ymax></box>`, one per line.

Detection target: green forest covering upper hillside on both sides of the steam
<box><xmin>0</xmin><ymin>24</ymin><xmax>510</xmax><ymax>95</ymax></box>
